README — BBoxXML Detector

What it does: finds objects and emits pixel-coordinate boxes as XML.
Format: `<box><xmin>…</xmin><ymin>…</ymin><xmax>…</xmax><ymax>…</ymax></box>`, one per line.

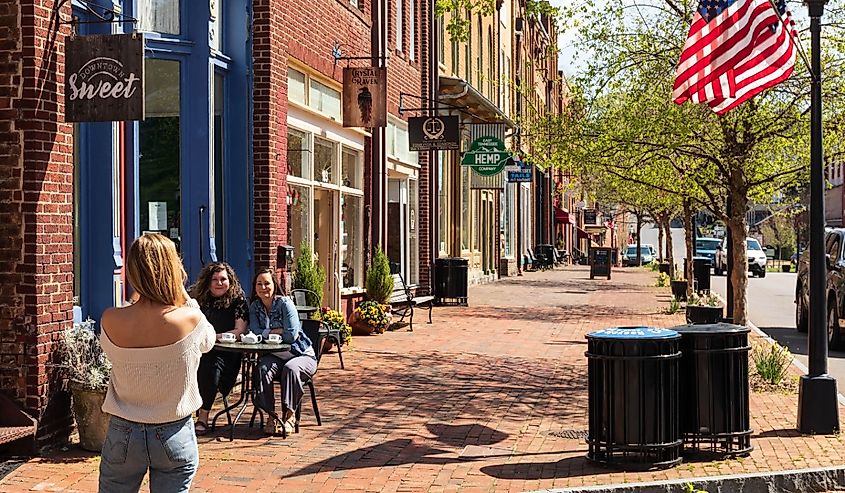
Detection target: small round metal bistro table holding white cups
<box><xmin>211</xmin><ymin>341</ymin><xmax>290</xmax><ymax>441</ymax></box>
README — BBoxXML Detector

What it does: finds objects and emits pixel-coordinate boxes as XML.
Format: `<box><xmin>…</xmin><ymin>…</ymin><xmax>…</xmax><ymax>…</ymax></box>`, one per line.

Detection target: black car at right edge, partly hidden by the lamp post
<box><xmin>795</xmin><ymin>228</ymin><xmax>845</xmax><ymax>349</ymax></box>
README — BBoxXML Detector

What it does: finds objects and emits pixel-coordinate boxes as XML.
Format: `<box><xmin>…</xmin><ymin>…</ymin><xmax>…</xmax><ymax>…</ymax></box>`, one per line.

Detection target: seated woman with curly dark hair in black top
<box><xmin>190</xmin><ymin>262</ymin><xmax>249</xmax><ymax>435</ymax></box>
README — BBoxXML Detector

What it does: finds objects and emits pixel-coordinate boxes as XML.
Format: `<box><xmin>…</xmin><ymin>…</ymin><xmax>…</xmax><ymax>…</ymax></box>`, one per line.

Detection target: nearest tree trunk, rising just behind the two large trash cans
<box><xmin>726</xmin><ymin>190</ymin><xmax>748</xmax><ymax>325</ymax></box>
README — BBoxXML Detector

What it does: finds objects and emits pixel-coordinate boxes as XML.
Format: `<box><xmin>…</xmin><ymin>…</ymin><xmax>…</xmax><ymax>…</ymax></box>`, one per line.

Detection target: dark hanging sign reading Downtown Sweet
<box><xmin>65</xmin><ymin>34</ymin><xmax>144</xmax><ymax>122</ymax></box>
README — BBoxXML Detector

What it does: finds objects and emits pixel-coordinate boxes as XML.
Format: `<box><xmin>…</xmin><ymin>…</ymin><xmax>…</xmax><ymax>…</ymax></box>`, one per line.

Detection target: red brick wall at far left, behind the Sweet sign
<box><xmin>0</xmin><ymin>0</ymin><xmax>73</xmax><ymax>442</ymax></box>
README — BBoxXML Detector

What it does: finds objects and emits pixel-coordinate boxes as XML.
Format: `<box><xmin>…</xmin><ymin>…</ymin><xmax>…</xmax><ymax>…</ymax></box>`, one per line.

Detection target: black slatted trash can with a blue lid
<box><xmin>586</xmin><ymin>327</ymin><xmax>683</xmax><ymax>469</ymax></box>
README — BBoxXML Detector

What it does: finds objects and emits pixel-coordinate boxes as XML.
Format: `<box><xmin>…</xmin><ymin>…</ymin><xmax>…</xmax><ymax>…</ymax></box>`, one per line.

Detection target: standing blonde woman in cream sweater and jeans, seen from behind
<box><xmin>99</xmin><ymin>233</ymin><xmax>215</xmax><ymax>493</ymax></box>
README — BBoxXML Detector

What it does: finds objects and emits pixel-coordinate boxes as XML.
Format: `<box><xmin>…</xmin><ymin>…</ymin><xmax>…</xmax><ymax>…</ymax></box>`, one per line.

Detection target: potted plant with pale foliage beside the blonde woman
<box><xmin>60</xmin><ymin>319</ymin><xmax>111</xmax><ymax>452</ymax></box>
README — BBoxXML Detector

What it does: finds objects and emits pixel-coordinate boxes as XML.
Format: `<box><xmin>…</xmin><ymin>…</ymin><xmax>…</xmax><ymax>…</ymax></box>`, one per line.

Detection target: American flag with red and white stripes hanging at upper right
<box><xmin>672</xmin><ymin>0</ymin><xmax>798</xmax><ymax>115</ymax></box>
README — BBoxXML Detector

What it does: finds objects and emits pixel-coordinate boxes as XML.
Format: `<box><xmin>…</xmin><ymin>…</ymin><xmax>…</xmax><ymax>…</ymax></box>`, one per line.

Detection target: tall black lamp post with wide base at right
<box><xmin>798</xmin><ymin>0</ymin><xmax>839</xmax><ymax>434</ymax></box>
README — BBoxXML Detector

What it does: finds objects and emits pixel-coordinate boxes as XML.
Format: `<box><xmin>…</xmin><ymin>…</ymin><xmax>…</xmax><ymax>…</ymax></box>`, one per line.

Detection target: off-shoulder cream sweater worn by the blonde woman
<box><xmin>100</xmin><ymin>315</ymin><xmax>216</xmax><ymax>423</ymax></box>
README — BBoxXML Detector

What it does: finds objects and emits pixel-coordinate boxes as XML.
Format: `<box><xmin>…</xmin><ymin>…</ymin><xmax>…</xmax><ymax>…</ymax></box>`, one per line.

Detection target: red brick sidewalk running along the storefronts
<box><xmin>0</xmin><ymin>267</ymin><xmax>845</xmax><ymax>493</ymax></box>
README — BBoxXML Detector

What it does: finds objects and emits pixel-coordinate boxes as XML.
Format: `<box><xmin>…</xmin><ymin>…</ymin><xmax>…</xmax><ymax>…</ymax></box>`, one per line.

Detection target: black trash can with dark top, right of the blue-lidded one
<box><xmin>672</xmin><ymin>323</ymin><xmax>753</xmax><ymax>456</ymax></box>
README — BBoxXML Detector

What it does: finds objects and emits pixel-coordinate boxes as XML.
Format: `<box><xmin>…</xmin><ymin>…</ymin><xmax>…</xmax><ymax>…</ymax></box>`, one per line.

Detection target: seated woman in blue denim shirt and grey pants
<box><xmin>249</xmin><ymin>269</ymin><xmax>317</xmax><ymax>434</ymax></box>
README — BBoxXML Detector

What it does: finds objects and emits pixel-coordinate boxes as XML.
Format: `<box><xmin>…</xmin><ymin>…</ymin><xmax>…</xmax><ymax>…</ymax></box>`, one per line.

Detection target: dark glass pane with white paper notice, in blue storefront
<box><xmin>138</xmin><ymin>59</ymin><xmax>182</xmax><ymax>248</ymax></box>
